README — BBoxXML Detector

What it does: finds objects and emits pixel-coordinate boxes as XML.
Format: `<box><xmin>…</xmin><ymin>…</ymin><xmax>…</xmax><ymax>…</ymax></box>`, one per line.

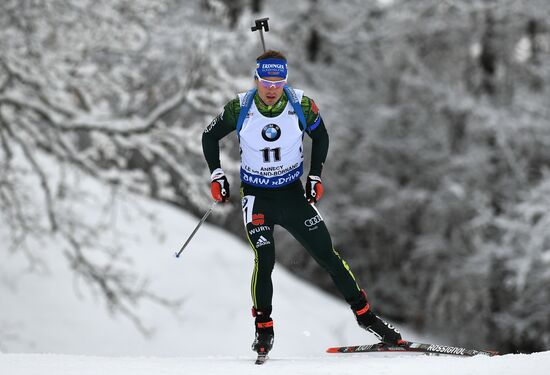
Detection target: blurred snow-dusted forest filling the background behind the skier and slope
<box><xmin>0</xmin><ymin>0</ymin><xmax>550</xmax><ymax>351</ymax></box>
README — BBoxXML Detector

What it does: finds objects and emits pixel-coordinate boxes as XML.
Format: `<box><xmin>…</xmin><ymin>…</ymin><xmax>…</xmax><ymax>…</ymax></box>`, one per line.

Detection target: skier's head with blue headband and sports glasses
<box><xmin>254</xmin><ymin>50</ymin><xmax>288</xmax><ymax>105</ymax></box>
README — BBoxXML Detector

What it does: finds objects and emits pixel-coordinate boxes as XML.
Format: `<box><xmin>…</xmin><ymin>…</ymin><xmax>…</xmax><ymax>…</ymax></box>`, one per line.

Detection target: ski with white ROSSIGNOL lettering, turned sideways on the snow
<box><xmin>327</xmin><ymin>341</ymin><xmax>499</xmax><ymax>357</ymax></box>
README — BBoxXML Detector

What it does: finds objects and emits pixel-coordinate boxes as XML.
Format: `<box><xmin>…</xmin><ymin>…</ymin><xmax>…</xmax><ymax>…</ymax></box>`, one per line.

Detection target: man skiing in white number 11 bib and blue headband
<box><xmin>202</xmin><ymin>50</ymin><xmax>404</xmax><ymax>354</ymax></box>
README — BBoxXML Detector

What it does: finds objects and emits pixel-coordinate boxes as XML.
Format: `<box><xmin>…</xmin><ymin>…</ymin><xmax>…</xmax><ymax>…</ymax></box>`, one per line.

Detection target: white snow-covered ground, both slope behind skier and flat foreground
<box><xmin>0</xmin><ymin>178</ymin><xmax>550</xmax><ymax>375</ymax></box>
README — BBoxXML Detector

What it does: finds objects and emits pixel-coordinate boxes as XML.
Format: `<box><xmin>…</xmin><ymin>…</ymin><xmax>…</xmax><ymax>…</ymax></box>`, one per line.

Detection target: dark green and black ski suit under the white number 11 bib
<box><xmin>202</xmin><ymin>89</ymin><xmax>364</xmax><ymax>311</ymax></box>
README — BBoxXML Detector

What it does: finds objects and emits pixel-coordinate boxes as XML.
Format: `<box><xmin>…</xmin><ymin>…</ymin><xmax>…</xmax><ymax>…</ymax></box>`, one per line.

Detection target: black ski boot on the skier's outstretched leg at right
<box><xmin>352</xmin><ymin>290</ymin><xmax>406</xmax><ymax>345</ymax></box>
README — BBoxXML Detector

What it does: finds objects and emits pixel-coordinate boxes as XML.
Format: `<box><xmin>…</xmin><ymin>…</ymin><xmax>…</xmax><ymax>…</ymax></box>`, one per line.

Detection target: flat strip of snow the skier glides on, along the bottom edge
<box><xmin>0</xmin><ymin>352</ymin><xmax>550</xmax><ymax>375</ymax></box>
